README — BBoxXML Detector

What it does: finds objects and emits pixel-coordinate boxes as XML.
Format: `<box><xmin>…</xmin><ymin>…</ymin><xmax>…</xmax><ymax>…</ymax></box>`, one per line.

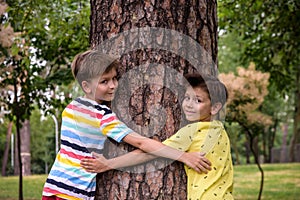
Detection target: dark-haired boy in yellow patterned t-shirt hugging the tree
<box><xmin>81</xmin><ymin>75</ymin><xmax>233</xmax><ymax>200</ymax></box>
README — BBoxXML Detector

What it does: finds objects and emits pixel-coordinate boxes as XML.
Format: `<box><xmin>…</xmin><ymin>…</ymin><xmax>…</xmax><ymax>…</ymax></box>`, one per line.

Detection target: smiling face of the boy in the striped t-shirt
<box><xmin>86</xmin><ymin>68</ymin><xmax>118</xmax><ymax>103</ymax></box>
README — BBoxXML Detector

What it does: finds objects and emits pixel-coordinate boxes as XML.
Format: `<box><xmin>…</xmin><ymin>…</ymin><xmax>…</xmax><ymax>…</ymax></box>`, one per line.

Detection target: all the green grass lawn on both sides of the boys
<box><xmin>0</xmin><ymin>163</ymin><xmax>300</xmax><ymax>200</ymax></box>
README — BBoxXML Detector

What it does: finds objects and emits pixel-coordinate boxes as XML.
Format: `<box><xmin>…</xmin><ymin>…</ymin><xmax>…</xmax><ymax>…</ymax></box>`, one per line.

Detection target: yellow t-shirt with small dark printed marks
<box><xmin>163</xmin><ymin>121</ymin><xmax>233</xmax><ymax>200</ymax></box>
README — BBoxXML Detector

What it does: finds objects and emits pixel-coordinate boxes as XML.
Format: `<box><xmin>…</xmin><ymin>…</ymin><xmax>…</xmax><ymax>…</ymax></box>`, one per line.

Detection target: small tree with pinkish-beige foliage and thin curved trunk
<box><xmin>220</xmin><ymin>63</ymin><xmax>273</xmax><ymax>199</ymax></box>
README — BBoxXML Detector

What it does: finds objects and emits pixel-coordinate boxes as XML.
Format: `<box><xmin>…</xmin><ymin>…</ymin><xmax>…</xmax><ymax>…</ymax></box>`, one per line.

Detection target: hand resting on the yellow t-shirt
<box><xmin>182</xmin><ymin>152</ymin><xmax>211</xmax><ymax>174</ymax></box>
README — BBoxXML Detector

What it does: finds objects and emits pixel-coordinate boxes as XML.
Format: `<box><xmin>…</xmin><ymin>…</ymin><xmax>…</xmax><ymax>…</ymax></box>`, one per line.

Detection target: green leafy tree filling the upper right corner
<box><xmin>219</xmin><ymin>0</ymin><xmax>300</xmax><ymax>161</ymax></box>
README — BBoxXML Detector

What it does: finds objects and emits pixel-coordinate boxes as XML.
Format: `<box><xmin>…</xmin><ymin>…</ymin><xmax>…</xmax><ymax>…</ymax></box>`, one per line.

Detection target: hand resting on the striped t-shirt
<box><xmin>80</xmin><ymin>152</ymin><xmax>111</xmax><ymax>173</ymax></box>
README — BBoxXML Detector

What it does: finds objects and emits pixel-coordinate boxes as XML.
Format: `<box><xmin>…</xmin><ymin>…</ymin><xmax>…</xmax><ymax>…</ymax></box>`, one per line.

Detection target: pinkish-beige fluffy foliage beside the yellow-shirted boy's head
<box><xmin>220</xmin><ymin>63</ymin><xmax>272</xmax><ymax>126</ymax></box>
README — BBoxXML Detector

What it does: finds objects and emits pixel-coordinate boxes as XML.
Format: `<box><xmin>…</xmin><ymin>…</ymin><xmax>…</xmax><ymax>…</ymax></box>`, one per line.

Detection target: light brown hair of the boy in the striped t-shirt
<box><xmin>71</xmin><ymin>50</ymin><xmax>119</xmax><ymax>86</ymax></box>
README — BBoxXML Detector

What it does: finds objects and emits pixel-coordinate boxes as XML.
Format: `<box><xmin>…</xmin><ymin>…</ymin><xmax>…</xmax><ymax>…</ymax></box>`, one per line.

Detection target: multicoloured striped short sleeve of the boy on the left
<box><xmin>100</xmin><ymin>112</ymin><xmax>133</xmax><ymax>142</ymax></box>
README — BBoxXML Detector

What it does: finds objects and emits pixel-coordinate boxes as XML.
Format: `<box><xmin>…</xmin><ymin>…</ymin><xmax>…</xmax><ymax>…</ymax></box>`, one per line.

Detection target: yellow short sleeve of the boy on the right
<box><xmin>163</xmin><ymin>123</ymin><xmax>197</xmax><ymax>151</ymax></box>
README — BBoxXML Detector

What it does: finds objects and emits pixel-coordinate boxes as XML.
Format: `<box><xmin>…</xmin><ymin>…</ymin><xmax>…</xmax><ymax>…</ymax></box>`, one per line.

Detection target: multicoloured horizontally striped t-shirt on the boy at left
<box><xmin>43</xmin><ymin>98</ymin><xmax>132</xmax><ymax>199</ymax></box>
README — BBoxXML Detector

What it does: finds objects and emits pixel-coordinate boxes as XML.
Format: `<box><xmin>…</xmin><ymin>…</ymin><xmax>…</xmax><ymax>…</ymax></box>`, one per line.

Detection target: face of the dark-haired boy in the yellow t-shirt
<box><xmin>182</xmin><ymin>87</ymin><xmax>211</xmax><ymax>122</ymax></box>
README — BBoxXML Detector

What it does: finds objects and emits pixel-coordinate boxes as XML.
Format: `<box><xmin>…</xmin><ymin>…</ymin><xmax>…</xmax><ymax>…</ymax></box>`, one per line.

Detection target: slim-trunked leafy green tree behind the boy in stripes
<box><xmin>0</xmin><ymin>1</ymin><xmax>89</xmax><ymax>199</ymax></box>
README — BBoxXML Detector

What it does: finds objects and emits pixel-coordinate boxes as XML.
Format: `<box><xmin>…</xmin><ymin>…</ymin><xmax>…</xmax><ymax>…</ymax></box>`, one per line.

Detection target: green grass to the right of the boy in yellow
<box><xmin>234</xmin><ymin>163</ymin><xmax>300</xmax><ymax>200</ymax></box>
